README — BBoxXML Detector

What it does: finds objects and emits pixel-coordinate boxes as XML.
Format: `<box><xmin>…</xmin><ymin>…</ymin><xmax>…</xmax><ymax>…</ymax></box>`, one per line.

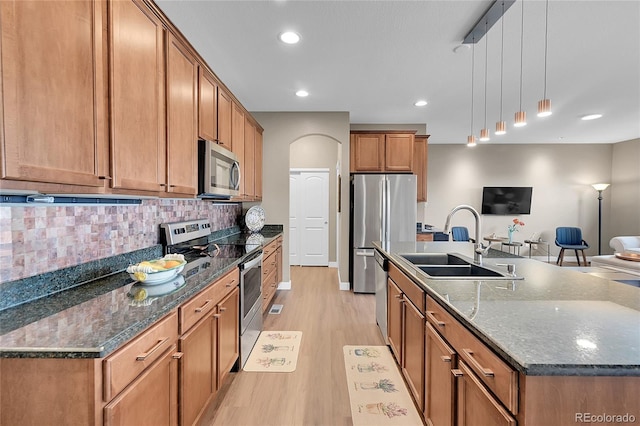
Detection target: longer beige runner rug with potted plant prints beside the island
<box><xmin>343</xmin><ymin>346</ymin><xmax>422</xmax><ymax>426</ymax></box>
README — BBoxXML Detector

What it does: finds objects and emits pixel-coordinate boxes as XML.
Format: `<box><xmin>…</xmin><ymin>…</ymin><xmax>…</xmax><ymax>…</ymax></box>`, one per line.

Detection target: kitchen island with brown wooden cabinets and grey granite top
<box><xmin>374</xmin><ymin>242</ymin><xmax>640</xmax><ymax>425</ymax></box>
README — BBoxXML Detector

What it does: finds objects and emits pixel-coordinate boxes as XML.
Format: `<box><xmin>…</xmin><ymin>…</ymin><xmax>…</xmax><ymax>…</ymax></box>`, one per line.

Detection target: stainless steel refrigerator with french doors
<box><xmin>350</xmin><ymin>174</ymin><xmax>417</xmax><ymax>293</ymax></box>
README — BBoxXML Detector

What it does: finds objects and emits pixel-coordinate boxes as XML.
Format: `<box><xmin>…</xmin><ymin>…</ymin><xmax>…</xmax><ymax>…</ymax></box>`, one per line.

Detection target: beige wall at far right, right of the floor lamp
<box><xmin>602</xmin><ymin>139</ymin><xmax>640</xmax><ymax>238</ymax></box>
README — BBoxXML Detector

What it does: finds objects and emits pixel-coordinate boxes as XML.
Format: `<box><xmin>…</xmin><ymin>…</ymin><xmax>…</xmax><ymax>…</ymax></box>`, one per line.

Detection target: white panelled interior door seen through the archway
<box><xmin>289</xmin><ymin>169</ymin><xmax>329</xmax><ymax>266</ymax></box>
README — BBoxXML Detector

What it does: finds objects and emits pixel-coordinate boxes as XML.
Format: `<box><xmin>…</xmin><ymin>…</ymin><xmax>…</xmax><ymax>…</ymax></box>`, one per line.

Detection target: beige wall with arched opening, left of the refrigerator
<box><xmin>252</xmin><ymin>112</ymin><xmax>349</xmax><ymax>282</ymax></box>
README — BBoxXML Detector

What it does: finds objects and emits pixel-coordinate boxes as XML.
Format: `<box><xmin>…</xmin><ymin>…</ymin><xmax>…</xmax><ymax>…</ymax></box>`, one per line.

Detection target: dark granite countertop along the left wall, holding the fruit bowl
<box><xmin>0</xmin><ymin>230</ymin><xmax>281</xmax><ymax>358</ymax></box>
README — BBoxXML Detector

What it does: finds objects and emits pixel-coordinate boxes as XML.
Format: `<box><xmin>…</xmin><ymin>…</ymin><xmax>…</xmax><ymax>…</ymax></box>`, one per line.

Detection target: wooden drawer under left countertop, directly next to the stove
<box><xmin>179</xmin><ymin>269</ymin><xmax>240</xmax><ymax>334</ymax></box>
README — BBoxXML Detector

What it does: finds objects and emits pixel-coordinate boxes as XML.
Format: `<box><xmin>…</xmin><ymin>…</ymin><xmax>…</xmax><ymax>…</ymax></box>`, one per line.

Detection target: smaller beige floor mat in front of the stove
<box><xmin>243</xmin><ymin>331</ymin><xmax>302</xmax><ymax>373</ymax></box>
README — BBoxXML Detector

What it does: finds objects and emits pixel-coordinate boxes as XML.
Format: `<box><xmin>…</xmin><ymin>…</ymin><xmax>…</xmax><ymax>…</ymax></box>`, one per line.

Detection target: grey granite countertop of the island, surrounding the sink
<box><xmin>374</xmin><ymin>242</ymin><xmax>640</xmax><ymax>376</ymax></box>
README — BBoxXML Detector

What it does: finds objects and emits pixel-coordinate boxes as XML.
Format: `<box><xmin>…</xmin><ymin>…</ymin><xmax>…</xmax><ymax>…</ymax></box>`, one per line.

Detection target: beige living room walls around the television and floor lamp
<box><xmin>419</xmin><ymin>140</ymin><xmax>640</xmax><ymax>255</ymax></box>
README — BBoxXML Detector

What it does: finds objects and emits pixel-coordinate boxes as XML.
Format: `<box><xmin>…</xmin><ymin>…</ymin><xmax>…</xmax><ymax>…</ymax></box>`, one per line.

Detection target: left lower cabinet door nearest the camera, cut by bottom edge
<box><xmin>104</xmin><ymin>345</ymin><xmax>178</xmax><ymax>426</ymax></box>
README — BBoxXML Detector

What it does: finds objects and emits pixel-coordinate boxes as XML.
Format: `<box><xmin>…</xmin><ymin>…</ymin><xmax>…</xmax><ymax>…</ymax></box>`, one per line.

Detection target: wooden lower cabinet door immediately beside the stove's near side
<box><xmin>217</xmin><ymin>287</ymin><xmax>240</xmax><ymax>388</ymax></box>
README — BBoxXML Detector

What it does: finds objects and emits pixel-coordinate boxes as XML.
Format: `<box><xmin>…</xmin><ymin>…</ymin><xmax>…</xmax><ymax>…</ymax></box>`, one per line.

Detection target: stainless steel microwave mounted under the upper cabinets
<box><xmin>198</xmin><ymin>140</ymin><xmax>240</xmax><ymax>199</ymax></box>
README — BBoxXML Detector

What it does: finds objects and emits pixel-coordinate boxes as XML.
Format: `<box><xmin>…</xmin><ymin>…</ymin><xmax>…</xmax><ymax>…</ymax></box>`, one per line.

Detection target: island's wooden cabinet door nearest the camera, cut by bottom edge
<box><xmin>453</xmin><ymin>361</ymin><xmax>516</xmax><ymax>426</ymax></box>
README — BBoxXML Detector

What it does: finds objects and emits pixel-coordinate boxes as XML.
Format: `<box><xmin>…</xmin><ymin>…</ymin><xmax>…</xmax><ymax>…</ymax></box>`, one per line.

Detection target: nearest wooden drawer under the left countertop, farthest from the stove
<box><xmin>103</xmin><ymin>311</ymin><xmax>178</xmax><ymax>401</ymax></box>
